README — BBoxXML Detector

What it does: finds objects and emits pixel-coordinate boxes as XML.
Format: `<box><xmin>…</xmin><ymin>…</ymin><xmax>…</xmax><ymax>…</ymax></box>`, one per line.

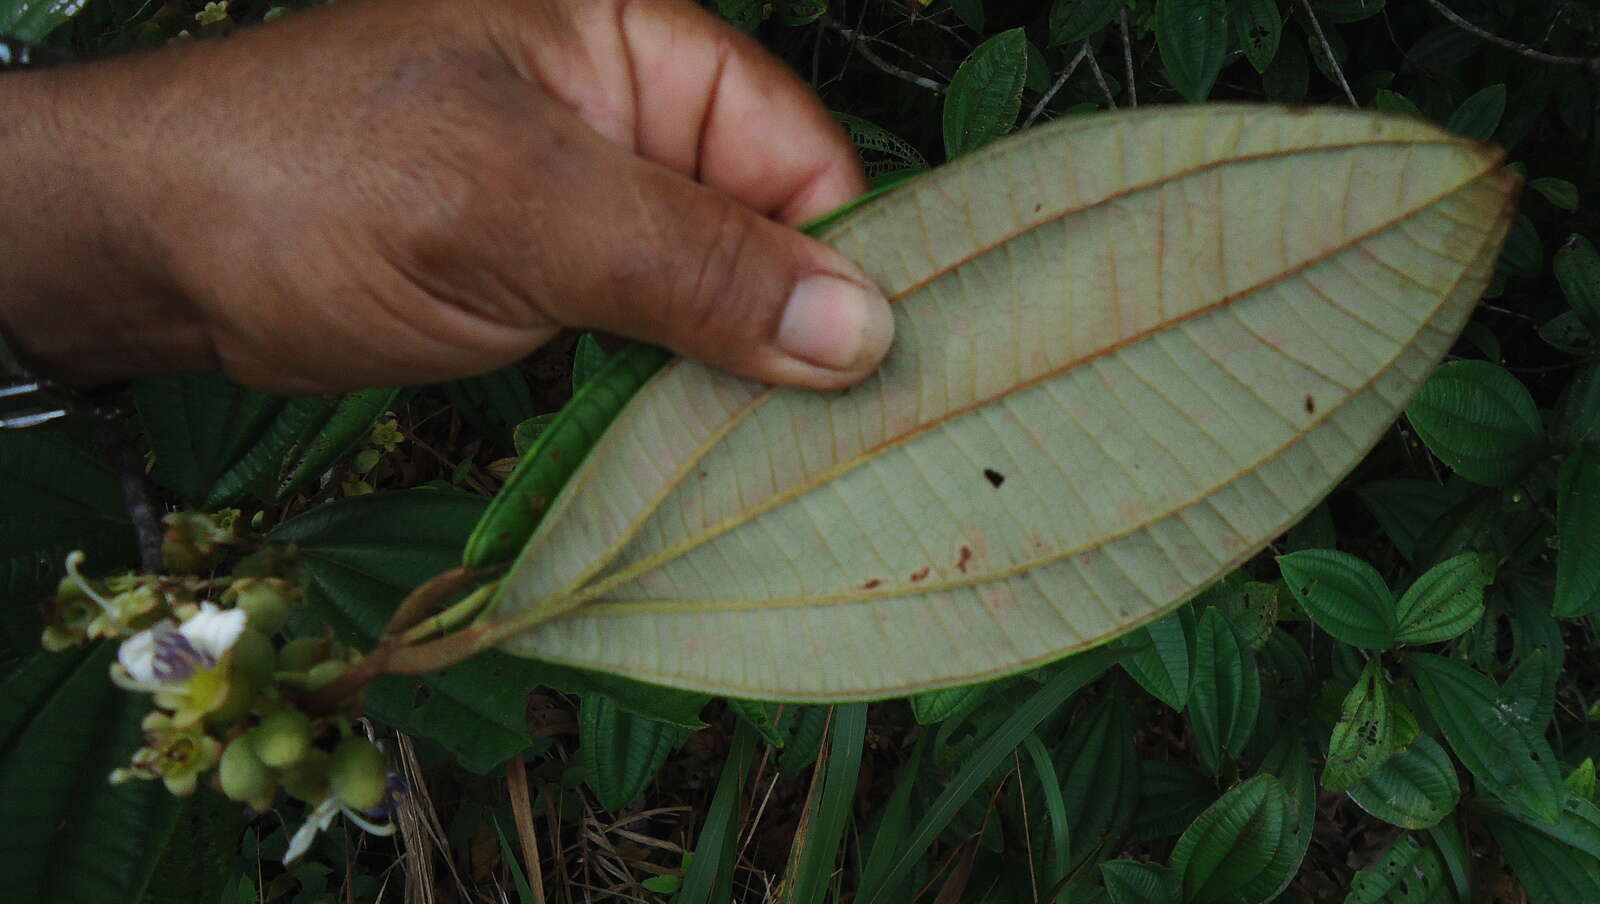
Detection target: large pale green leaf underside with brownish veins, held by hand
<box><xmin>498</xmin><ymin>107</ymin><xmax>1515</xmax><ymax>699</ymax></box>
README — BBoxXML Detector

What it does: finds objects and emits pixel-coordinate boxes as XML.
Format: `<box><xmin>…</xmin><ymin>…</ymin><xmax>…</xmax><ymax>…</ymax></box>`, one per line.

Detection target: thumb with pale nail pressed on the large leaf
<box><xmin>542</xmin><ymin>160</ymin><xmax>894</xmax><ymax>389</ymax></box>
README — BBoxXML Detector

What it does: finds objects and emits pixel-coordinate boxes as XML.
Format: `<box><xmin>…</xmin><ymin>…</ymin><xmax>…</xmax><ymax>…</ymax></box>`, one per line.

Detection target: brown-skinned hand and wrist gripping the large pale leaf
<box><xmin>0</xmin><ymin>0</ymin><xmax>893</xmax><ymax>394</ymax></box>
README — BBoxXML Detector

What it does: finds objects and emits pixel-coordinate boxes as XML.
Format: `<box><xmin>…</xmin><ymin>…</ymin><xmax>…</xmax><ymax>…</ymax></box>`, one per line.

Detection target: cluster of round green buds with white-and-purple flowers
<box><xmin>43</xmin><ymin>512</ymin><xmax>405</xmax><ymax>862</ymax></box>
